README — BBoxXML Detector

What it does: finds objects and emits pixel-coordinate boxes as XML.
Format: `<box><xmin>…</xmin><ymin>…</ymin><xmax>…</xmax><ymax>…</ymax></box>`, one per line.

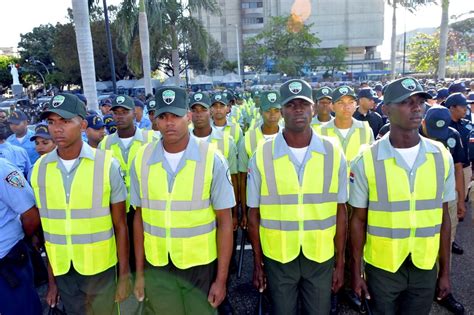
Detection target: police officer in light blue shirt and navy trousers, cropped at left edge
<box><xmin>0</xmin><ymin>158</ymin><xmax>42</xmax><ymax>315</ymax></box>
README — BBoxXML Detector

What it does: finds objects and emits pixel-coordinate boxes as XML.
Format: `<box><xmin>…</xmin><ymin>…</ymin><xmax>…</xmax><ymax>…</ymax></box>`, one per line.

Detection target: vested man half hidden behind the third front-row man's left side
<box><xmin>239</xmin><ymin>91</ymin><xmax>282</xmax><ymax>229</ymax></box>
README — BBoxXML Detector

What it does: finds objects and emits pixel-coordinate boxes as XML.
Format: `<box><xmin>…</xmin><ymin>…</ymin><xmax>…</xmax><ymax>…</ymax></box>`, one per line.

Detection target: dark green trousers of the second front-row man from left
<box><xmin>145</xmin><ymin>260</ymin><xmax>217</xmax><ymax>315</ymax></box>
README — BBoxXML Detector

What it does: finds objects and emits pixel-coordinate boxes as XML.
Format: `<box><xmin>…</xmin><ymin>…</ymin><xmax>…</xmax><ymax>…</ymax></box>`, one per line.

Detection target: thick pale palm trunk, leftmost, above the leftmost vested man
<box><xmin>72</xmin><ymin>0</ymin><xmax>99</xmax><ymax>111</ymax></box>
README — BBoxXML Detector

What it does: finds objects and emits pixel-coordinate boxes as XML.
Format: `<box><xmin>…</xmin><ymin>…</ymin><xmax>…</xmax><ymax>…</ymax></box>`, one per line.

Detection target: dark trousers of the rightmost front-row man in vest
<box><xmin>365</xmin><ymin>256</ymin><xmax>437</xmax><ymax>315</ymax></box>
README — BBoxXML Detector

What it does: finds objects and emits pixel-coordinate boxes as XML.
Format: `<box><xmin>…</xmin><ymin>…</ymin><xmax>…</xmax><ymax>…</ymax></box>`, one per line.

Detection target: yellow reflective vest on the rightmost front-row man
<box><xmin>361</xmin><ymin>139</ymin><xmax>449</xmax><ymax>272</ymax></box>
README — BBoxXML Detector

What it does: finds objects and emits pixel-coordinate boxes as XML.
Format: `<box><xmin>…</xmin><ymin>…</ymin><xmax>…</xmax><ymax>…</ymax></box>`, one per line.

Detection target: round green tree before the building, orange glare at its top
<box><xmin>244</xmin><ymin>16</ymin><xmax>321</xmax><ymax>76</ymax></box>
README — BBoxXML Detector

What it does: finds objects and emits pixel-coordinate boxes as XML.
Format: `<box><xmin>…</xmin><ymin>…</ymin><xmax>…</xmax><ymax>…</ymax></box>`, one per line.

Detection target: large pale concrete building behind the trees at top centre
<box><xmin>193</xmin><ymin>0</ymin><xmax>385</xmax><ymax>70</ymax></box>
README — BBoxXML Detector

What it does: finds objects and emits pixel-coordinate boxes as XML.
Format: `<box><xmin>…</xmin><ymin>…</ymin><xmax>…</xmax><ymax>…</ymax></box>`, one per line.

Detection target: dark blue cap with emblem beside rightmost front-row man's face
<box><xmin>425</xmin><ymin>105</ymin><xmax>451</xmax><ymax>140</ymax></box>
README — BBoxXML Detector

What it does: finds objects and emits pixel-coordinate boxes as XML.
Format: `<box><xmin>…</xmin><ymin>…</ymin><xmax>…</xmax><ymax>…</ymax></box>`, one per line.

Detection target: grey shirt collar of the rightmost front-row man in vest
<box><xmin>377</xmin><ymin>133</ymin><xmax>440</xmax><ymax>169</ymax></box>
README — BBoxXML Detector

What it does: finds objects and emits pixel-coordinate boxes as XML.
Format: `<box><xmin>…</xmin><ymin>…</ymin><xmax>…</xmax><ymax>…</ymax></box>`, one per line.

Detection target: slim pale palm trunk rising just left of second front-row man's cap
<box><xmin>138</xmin><ymin>0</ymin><xmax>153</xmax><ymax>95</ymax></box>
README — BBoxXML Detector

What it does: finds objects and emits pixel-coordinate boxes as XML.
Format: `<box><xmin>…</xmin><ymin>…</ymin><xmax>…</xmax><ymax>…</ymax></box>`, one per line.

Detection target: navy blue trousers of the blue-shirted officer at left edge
<box><xmin>0</xmin><ymin>241</ymin><xmax>42</xmax><ymax>315</ymax></box>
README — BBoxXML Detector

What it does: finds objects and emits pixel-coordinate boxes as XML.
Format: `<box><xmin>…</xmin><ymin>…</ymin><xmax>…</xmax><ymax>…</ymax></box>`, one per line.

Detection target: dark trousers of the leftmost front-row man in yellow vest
<box><xmin>56</xmin><ymin>265</ymin><xmax>117</xmax><ymax>315</ymax></box>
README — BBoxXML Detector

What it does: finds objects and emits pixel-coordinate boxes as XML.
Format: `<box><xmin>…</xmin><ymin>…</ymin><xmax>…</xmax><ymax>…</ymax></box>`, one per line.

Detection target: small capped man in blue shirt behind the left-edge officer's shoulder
<box><xmin>7</xmin><ymin>110</ymin><xmax>39</xmax><ymax>164</ymax></box>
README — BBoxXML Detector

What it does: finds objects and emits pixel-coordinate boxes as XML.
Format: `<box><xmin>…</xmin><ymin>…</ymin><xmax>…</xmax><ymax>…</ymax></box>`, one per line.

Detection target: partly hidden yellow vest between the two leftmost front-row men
<box><xmin>99</xmin><ymin>130</ymin><xmax>154</xmax><ymax>212</ymax></box>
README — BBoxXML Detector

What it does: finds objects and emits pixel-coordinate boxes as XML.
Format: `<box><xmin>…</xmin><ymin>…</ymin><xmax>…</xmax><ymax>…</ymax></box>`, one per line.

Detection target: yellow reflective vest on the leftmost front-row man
<box><xmin>31</xmin><ymin>149</ymin><xmax>117</xmax><ymax>276</ymax></box>
